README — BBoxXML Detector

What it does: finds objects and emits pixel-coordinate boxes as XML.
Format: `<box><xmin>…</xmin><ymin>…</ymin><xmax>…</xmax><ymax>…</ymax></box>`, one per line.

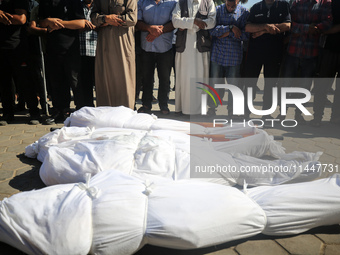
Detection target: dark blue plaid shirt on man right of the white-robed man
<box><xmin>210</xmin><ymin>4</ymin><xmax>249</xmax><ymax>66</ymax></box>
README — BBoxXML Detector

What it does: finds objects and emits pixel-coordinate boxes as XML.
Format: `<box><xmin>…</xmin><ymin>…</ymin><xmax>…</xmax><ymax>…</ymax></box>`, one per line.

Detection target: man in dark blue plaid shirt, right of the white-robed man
<box><xmin>208</xmin><ymin>0</ymin><xmax>249</xmax><ymax>115</ymax></box>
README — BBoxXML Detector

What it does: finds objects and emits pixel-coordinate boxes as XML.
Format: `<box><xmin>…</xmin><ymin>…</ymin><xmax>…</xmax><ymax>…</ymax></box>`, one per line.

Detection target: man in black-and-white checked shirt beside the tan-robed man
<box><xmin>79</xmin><ymin>0</ymin><xmax>97</xmax><ymax>107</ymax></box>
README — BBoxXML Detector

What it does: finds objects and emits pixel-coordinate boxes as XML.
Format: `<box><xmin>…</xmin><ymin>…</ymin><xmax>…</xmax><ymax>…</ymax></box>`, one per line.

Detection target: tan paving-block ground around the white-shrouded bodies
<box><xmin>0</xmin><ymin>77</ymin><xmax>340</xmax><ymax>255</ymax></box>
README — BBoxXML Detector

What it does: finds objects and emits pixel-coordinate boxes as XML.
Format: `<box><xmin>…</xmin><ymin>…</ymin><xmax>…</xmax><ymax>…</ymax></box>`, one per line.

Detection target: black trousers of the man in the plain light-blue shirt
<box><xmin>142</xmin><ymin>49</ymin><xmax>173</xmax><ymax>110</ymax></box>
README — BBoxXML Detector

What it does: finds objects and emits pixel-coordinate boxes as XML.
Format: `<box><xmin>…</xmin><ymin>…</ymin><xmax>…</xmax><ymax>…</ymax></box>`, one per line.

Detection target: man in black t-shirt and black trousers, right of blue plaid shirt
<box><xmin>245</xmin><ymin>0</ymin><xmax>291</xmax><ymax>118</ymax></box>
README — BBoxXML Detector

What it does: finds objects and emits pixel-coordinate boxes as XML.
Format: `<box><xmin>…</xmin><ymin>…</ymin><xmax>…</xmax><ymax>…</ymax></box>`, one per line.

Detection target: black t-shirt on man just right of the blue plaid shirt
<box><xmin>248</xmin><ymin>0</ymin><xmax>291</xmax><ymax>57</ymax></box>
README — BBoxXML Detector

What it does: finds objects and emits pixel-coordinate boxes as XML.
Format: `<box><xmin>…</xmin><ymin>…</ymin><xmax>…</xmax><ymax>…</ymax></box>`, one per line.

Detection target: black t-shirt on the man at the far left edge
<box><xmin>0</xmin><ymin>0</ymin><xmax>28</xmax><ymax>50</ymax></box>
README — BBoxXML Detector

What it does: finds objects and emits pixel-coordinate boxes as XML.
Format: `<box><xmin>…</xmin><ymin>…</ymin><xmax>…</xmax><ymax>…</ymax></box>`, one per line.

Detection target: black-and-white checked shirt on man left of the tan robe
<box><xmin>79</xmin><ymin>2</ymin><xmax>97</xmax><ymax>57</ymax></box>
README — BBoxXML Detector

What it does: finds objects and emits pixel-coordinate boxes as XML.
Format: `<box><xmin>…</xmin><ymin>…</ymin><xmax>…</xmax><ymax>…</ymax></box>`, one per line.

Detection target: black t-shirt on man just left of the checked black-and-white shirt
<box><xmin>39</xmin><ymin>0</ymin><xmax>84</xmax><ymax>54</ymax></box>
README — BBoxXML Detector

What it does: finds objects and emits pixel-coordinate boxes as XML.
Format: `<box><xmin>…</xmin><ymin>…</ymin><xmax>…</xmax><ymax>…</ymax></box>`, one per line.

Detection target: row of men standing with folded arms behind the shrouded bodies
<box><xmin>0</xmin><ymin>0</ymin><xmax>340</xmax><ymax>127</ymax></box>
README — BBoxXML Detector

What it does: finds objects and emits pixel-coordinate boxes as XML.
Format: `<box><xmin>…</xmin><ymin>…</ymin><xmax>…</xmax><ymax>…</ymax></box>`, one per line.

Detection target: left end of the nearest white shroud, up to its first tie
<box><xmin>0</xmin><ymin>184</ymin><xmax>93</xmax><ymax>255</ymax></box>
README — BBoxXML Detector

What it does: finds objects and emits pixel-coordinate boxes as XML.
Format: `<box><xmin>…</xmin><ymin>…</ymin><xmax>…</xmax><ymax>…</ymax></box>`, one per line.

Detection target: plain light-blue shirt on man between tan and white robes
<box><xmin>138</xmin><ymin>0</ymin><xmax>177</xmax><ymax>53</ymax></box>
